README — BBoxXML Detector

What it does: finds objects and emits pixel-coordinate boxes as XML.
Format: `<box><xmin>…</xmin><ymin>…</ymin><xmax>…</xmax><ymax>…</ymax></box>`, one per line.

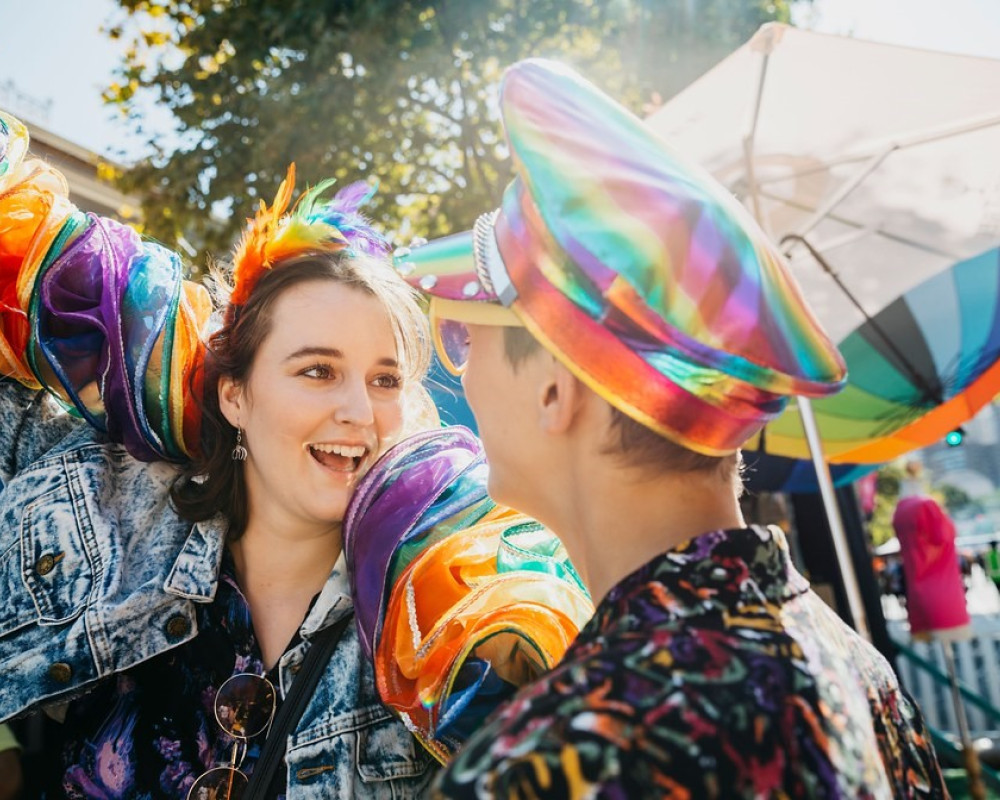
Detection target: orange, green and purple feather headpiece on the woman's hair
<box><xmin>229</xmin><ymin>163</ymin><xmax>389</xmax><ymax>306</ymax></box>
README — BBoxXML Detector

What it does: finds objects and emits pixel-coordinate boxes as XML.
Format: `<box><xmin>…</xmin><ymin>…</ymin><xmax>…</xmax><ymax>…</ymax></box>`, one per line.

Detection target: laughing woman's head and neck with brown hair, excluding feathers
<box><xmin>180</xmin><ymin>247</ymin><xmax>427</xmax><ymax>668</ymax></box>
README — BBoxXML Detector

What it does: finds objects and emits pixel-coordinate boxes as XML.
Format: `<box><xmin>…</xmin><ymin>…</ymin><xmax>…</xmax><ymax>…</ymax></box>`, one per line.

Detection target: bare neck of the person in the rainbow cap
<box><xmin>547</xmin><ymin>465</ymin><xmax>745</xmax><ymax>604</ymax></box>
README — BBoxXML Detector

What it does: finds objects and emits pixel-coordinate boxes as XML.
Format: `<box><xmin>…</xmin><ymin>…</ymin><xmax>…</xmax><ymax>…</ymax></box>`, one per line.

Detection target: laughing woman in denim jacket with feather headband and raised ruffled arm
<box><xmin>0</xmin><ymin>145</ymin><xmax>440</xmax><ymax>797</ymax></box>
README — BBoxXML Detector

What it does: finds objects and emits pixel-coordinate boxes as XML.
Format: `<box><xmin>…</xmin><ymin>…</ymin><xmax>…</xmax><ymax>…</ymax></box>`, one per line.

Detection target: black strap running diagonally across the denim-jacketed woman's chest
<box><xmin>243</xmin><ymin>614</ymin><xmax>354</xmax><ymax>800</ymax></box>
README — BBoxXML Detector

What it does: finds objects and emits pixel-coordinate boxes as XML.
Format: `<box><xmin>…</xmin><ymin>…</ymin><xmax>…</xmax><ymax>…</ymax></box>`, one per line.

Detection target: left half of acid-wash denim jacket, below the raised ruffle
<box><xmin>0</xmin><ymin>381</ymin><xmax>224</xmax><ymax>721</ymax></box>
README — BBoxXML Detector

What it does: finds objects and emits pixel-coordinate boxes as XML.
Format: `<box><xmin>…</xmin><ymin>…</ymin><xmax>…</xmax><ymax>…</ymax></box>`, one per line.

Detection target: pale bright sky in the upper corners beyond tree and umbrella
<box><xmin>0</xmin><ymin>0</ymin><xmax>1000</xmax><ymax>161</ymax></box>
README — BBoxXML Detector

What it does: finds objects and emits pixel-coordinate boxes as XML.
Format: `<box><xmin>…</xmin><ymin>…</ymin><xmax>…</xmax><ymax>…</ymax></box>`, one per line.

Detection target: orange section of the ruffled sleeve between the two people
<box><xmin>375</xmin><ymin>507</ymin><xmax>594</xmax><ymax>762</ymax></box>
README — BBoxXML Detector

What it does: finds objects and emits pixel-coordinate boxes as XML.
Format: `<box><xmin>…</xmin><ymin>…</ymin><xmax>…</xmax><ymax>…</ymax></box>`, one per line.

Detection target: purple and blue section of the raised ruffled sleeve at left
<box><xmin>33</xmin><ymin>215</ymin><xmax>183</xmax><ymax>461</ymax></box>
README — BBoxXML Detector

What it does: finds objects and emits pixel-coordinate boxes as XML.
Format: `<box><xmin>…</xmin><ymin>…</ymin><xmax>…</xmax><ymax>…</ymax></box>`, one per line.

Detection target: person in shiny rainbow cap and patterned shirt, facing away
<box><xmin>397</xmin><ymin>60</ymin><xmax>946</xmax><ymax>798</ymax></box>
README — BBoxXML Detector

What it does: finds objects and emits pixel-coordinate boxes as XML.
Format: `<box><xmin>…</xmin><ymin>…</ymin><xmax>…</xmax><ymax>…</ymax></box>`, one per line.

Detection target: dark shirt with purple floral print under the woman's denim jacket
<box><xmin>53</xmin><ymin>552</ymin><xmax>297</xmax><ymax>800</ymax></box>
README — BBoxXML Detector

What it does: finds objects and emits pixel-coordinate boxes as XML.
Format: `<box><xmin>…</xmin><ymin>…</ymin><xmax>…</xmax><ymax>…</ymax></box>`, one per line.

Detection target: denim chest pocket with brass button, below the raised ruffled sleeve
<box><xmin>21</xmin><ymin>488</ymin><xmax>94</xmax><ymax>625</ymax></box>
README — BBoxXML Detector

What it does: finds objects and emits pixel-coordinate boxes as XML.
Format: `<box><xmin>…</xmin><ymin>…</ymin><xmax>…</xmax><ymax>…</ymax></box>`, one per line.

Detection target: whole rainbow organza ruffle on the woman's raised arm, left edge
<box><xmin>0</xmin><ymin>108</ymin><xmax>212</xmax><ymax>461</ymax></box>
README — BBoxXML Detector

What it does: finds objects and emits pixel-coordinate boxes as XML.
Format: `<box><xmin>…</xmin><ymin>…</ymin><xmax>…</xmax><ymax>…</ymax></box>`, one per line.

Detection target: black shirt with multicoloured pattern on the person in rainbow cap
<box><xmin>435</xmin><ymin>528</ymin><xmax>947</xmax><ymax>800</ymax></box>
